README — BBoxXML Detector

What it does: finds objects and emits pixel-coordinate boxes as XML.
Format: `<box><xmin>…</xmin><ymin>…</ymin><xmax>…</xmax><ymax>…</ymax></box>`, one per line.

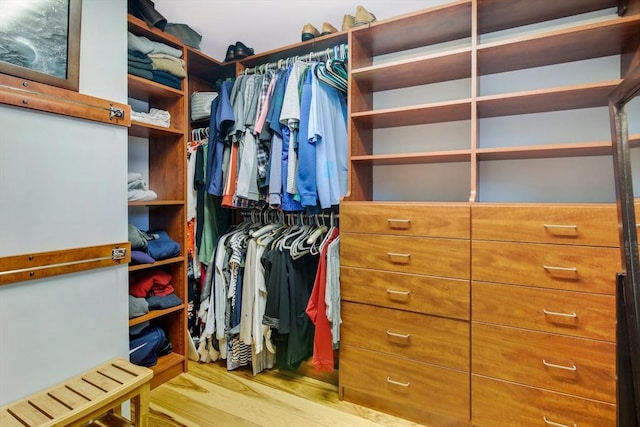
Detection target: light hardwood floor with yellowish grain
<box><xmin>149</xmin><ymin>362</ymin><xmax>419</xmax><ymax>427</ymax></box>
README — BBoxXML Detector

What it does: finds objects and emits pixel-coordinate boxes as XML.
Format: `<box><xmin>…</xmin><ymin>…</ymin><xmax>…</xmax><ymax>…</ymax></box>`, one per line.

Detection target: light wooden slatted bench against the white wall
<box><xmin>0</xmin><ymin>359</ymin><xmax>153</xmax><ymax>427</ymax></box>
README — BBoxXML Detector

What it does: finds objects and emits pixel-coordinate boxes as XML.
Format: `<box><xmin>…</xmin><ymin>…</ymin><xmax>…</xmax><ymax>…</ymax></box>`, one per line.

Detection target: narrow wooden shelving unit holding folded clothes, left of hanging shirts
<box><xmin>127</xmin><ymin>15</ymin><xmax>188</xmax><ymax>387</ymax></box>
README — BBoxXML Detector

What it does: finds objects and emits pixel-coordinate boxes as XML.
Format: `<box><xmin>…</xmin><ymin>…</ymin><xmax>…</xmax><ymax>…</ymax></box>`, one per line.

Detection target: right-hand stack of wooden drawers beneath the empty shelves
<box><xmin>471</xmin><ymin>204</ymin><xmax>621</xmax><ymax>427</ymax></box>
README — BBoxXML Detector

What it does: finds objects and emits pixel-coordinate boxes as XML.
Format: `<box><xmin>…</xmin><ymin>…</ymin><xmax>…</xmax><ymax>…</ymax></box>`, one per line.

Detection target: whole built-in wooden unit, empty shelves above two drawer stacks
<box><xmin>339</xmin><ymin>0</ymin><xmax>640</xmax><ymax>426</ymax></box>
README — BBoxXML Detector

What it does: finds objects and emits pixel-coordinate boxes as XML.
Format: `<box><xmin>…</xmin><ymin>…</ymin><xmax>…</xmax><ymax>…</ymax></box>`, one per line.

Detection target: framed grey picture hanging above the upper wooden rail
<box><xmin>0</xmin><ymin>0</ymin><xmax>82</xmax><ymax>91</ymax></box>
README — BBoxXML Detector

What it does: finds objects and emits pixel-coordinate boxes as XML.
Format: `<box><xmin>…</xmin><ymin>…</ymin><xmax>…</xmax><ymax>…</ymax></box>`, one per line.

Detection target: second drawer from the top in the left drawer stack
<box><xmin>340</xmin><ymin>233</ymin><xmax>470</xmax><ymax>279</ymax></box>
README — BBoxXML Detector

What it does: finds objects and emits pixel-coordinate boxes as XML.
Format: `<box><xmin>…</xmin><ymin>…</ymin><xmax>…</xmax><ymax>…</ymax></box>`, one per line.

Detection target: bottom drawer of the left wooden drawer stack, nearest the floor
<box><xmin>339</xmin><ymin>345</ymin><xmax>470</xmax><ymax>426</ymax></box>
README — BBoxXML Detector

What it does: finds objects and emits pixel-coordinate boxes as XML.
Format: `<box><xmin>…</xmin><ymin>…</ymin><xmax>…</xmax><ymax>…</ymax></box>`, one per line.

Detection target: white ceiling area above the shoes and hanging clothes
<box><xmin>154</xmin><ymin>0</ymin><xmax>449</xmax><ymax>61</ymax></box>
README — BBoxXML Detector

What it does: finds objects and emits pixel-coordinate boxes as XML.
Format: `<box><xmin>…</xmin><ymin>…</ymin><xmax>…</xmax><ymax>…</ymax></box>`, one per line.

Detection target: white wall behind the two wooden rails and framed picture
<box><xmin>0</xmin><ymin>0</ymin><xmax>128</xmax><ymax>404</ymax></box>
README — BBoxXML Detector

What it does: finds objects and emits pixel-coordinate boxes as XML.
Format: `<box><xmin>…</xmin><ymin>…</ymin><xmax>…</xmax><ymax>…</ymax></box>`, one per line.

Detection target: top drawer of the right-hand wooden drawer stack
<box><xmin>471</xmin><ymin>204</ymin><xmax>620</xmax><ymax>246</ymax></box>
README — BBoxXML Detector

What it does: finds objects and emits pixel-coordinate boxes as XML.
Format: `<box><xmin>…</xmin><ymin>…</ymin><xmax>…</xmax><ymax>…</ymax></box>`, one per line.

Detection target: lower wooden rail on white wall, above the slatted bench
<box><xmin>0</xmin><ymin>242</ymin><xmax>131</xmax><ymax>286</ymax></box>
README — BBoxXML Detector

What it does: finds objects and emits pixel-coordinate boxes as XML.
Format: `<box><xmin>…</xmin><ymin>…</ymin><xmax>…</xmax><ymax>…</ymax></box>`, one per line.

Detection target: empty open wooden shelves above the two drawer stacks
<box><xmin>345</xmin><ymin>0</ymin><xmax>640</xmax><ymax>202</ymax></box>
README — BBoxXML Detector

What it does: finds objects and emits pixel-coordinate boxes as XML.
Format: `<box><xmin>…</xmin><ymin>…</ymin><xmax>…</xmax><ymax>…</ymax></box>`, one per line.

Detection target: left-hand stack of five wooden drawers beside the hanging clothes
<box><xmin>339</xmin><ymin>202</ymin><xmax>470</xmax><ymax>426</ymax></box>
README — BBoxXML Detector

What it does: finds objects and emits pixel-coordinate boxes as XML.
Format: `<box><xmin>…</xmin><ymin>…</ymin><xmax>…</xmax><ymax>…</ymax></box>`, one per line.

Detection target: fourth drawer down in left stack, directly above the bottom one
<box><xmin>340</xmin><ymin>302</ymin><xmax>469</xmax><ymax>371</ymax></box>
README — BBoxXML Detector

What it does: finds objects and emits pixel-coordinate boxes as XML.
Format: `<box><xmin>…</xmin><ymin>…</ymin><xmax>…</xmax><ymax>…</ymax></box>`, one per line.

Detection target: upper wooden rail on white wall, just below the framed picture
<box><xmin>0</xmin><ymin>74</ymin><xmax>131</xmax><ymax>127</ymax></box>
